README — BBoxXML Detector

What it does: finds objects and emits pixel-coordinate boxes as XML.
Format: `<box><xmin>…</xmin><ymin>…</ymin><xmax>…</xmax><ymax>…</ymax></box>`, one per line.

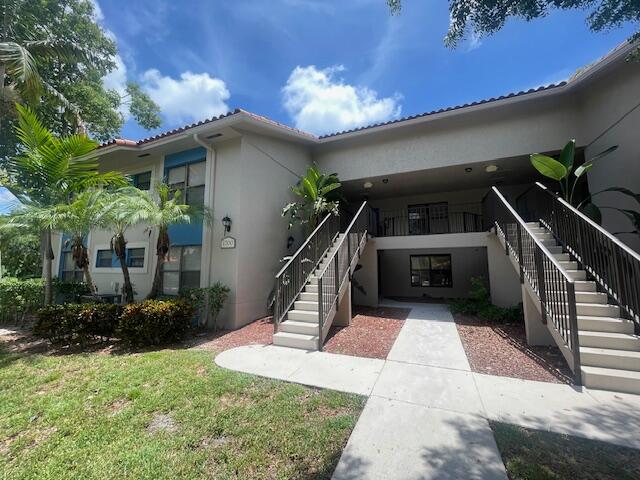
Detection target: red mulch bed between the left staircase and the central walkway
<box><xmin>324</xmin><ymin>306</ymin><xmax>411</xmax><ymax>360</ymax></box>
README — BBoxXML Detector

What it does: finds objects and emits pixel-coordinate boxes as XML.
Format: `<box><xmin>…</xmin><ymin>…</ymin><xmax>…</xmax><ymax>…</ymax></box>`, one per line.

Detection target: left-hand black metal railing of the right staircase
<box><xmin>483</xmin><ymin>187</ymin><xmax>581</xmax><ymax>384</ymax></box>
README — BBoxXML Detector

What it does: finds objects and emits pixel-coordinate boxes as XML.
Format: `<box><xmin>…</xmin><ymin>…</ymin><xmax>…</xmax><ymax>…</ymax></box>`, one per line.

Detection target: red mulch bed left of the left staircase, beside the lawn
<box><xmin>191</xmin><ymin>317</ymin><xmax>273</xmax><ymax>353</ymax></box>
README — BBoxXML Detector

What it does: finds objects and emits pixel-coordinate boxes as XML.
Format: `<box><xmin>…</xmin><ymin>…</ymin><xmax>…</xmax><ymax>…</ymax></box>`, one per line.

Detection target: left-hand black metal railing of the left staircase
<box><xmin>273</xmin><ymin>214</ymin><xmax>340</xmax><ymax>333</ymax></box>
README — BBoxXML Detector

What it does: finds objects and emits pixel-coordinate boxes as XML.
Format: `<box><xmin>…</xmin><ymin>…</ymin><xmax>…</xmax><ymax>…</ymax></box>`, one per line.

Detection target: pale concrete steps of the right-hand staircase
<box><xmin>527</xmin><ymin>222</ymin><xmax>640</xmax><ymax>394</ymax></box>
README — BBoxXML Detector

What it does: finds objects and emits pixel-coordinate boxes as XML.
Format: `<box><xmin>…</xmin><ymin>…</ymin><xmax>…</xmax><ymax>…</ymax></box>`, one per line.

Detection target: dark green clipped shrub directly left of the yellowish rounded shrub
<box><xmin>33</xmin><ymin>303</ymin><xmax>122</xmax><ymax>343</ymax></box>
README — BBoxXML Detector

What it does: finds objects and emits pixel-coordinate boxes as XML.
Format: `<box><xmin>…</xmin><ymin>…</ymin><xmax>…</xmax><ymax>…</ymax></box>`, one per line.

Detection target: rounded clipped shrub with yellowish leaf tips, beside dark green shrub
<box><xmin>118</xmin><ymin>300</ymin><xmax>195</xmax><ymax>345</ymax></box>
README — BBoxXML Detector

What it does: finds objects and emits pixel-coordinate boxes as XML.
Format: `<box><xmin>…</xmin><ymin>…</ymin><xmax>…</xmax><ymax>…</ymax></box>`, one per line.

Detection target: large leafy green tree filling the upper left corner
<box><xmin>0</xmin><ymin>0</ymin><xmax>161</xmax><ymax>159</ymax></box>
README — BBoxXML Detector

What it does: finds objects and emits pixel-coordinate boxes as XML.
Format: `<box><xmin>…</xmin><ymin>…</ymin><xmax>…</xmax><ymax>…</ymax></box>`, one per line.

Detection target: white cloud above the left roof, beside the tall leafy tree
<box><xmin>141</xmin><ymin>69</ymin><xmax>230</xmax><ymax>125</ymax></box>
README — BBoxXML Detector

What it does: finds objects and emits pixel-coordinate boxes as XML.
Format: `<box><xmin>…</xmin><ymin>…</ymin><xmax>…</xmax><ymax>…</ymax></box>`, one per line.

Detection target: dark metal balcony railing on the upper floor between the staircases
<box><xmin>374</xmin><ymin>207</ymin><xmax>483</xmax><ymax>237</ymax></box>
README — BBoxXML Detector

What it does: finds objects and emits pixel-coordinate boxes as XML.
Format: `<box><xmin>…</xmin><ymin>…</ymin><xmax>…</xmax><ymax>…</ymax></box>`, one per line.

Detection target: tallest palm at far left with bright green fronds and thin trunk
<box><xmin>2</xmin><ymin>105</ymin><xmax>127</xmax><ymax>303</ymax></box>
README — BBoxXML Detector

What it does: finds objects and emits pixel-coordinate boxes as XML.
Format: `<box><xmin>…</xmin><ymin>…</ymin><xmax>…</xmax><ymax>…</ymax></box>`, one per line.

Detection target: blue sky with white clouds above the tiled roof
<box><xmin>0</xmin><ymin>0</ymin><xmax>634</xmax><ymax>211</ymax></box>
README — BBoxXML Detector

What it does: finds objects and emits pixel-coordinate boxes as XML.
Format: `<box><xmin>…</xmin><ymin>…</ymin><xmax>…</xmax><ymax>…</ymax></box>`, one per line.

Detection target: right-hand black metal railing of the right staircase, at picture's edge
<box><xmin>527</xmin><ymin>183</ymin><xmax>640</xmax><ymax>333</ymax></box>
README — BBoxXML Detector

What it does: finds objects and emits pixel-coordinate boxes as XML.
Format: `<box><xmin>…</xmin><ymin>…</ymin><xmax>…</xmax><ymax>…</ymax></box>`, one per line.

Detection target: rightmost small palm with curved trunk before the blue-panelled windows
<box><xmin>139</xmin><ymin>182</ymin><xmax>211</xmax><ymax>299</ymax></box>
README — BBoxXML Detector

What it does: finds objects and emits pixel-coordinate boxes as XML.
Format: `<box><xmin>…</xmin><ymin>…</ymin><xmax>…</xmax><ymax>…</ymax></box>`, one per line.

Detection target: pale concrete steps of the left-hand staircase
<box><xmin>273</xmin><ymin>233</ymin><xmax>345</xmax><ymax>350</ymax></box>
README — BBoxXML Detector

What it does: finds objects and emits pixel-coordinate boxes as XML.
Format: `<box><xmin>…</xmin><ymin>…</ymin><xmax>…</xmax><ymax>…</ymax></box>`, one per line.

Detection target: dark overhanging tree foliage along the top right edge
<box><xmin>387</xmin><ymin>0</ymin><xmax>640</xmax><ymax>55</ymax></box>
